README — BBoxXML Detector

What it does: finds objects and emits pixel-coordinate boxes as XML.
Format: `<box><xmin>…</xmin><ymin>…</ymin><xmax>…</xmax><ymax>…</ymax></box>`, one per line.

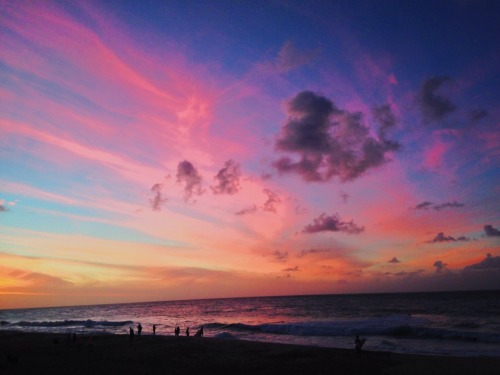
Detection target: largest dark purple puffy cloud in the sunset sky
<box><xmin>273</xmin><ymin>91</ymin><xmax>400</xmax><ymax>182</ymax></box>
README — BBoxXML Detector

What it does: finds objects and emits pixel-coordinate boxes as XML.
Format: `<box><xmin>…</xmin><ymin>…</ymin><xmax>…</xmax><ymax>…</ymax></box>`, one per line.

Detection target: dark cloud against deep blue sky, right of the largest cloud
<box><xmin>417</xmin><ymin>76</ymin><xmax>457</xmax><ymax>122</ymax></box>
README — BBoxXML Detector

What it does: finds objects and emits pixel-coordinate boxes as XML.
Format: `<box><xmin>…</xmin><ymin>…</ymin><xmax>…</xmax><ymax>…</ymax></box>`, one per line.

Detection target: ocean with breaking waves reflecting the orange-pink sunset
<box><xmin>0</xmin><ymin>291</ymin><xmax>500</xmax><ymax>357</ymax></box>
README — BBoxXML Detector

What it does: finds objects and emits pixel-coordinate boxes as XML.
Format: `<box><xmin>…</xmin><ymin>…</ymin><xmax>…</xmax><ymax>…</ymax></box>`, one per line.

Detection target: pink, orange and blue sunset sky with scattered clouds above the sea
<box><xmin>0</xmin><ymin>0</ymin><xmax>500</xmax><ymax>308</ymax></box>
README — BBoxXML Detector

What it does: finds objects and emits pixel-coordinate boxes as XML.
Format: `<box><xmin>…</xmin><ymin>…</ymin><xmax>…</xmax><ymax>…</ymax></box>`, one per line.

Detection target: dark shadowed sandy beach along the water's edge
<box><xmin>0</xmin><ymin>332</ymin><xmax>500</xmax><ymax>375</ymax></box>
